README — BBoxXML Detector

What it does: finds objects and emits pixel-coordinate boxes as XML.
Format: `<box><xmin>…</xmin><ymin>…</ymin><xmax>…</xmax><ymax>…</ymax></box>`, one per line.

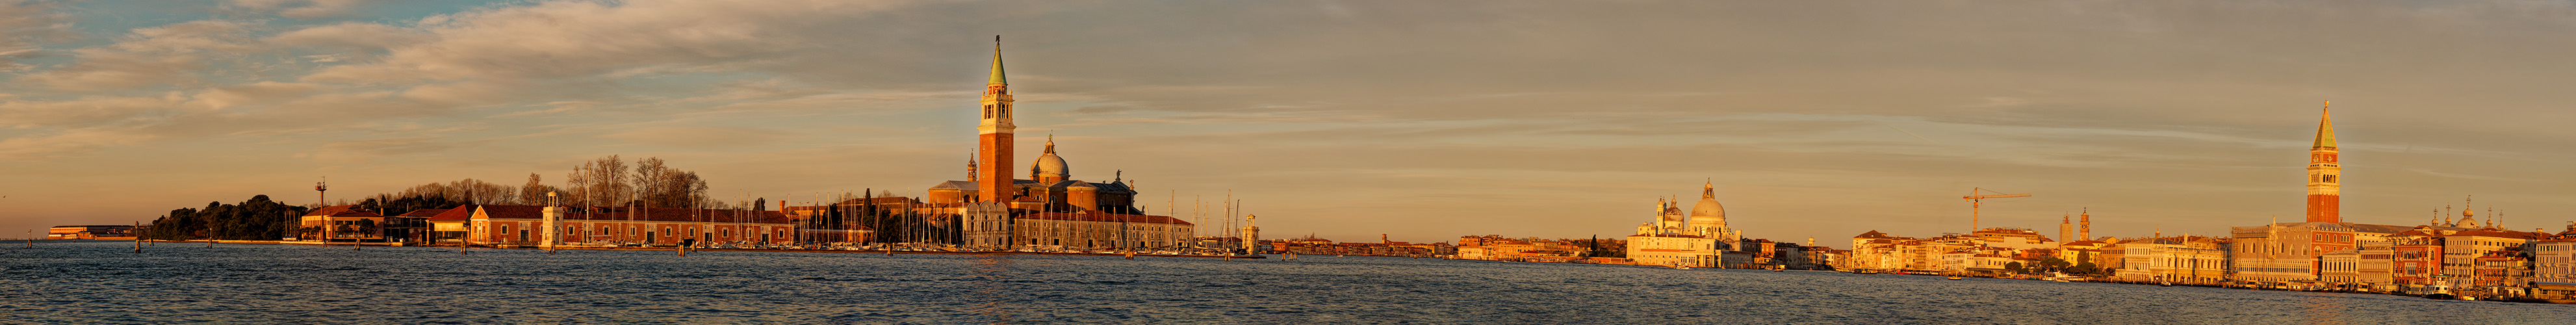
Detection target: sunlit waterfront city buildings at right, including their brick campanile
<box><xmin>1836</xmin><ymin>103</ymin><xmax>2576</xmax><ymax>299</ymax></box>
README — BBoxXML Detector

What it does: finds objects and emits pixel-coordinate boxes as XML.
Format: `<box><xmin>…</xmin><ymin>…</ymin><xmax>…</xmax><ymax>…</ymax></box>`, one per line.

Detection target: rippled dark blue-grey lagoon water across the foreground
<box><xmin>0</xmin><ymin>242</ymin><xmax>2576</xmax><ymax>325</ymax></box>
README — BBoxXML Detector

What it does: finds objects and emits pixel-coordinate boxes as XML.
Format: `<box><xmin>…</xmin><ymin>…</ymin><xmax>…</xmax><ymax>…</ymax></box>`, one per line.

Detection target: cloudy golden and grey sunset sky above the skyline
<box><xmin>0</xmin><ymin>0</ymin><xmax>2576</xmax><ymax>248</ymax></box>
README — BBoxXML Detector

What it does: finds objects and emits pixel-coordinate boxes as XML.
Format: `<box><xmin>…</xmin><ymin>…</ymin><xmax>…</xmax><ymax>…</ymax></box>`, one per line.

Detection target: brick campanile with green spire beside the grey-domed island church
<box><xmin>973</xmin><ymin>36</ymin><xmax>1020</xmax><ymax>202</ymax></box>
